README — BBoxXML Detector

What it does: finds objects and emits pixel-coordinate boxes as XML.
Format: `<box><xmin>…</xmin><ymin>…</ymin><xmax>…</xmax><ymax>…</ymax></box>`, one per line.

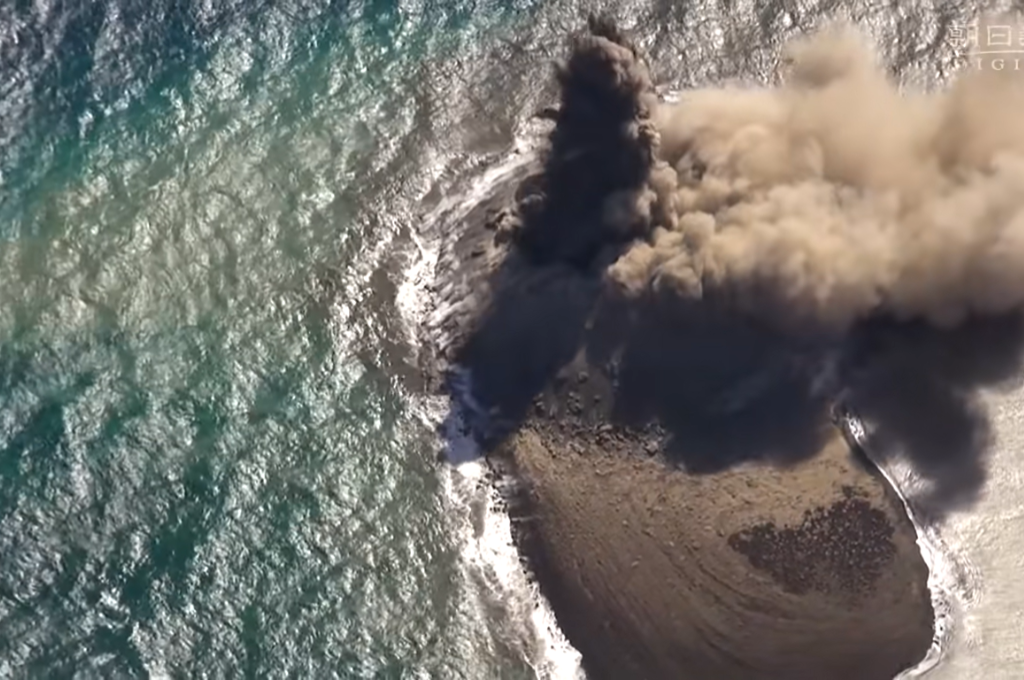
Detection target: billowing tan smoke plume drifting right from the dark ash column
<box><xmin>605</xmin><ymin>22</ymin><xmax>1024</xmax><ymax>331</ymax></box>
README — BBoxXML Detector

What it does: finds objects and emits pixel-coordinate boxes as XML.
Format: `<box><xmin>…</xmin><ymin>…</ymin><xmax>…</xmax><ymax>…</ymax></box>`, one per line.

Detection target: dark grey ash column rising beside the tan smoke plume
<box><xmin>518</xmin><ymin>13</ymin><xmax>657</xmax><ymax>267</ymax></box>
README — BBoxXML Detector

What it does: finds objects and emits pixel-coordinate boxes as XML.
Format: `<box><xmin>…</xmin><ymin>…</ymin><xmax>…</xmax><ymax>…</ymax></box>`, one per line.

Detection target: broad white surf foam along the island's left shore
<box><xmin>397</xmin><ymin>146</ymin><xmax>585</xmax><ymax>680</ymax></box>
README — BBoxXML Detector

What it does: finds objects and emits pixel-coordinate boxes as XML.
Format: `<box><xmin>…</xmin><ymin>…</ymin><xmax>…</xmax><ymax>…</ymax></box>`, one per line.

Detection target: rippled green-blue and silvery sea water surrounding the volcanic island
<box><xmin>0</xmin><ymin>0</ymin><xmax>1024</xmax><ymax>680</ymax></box>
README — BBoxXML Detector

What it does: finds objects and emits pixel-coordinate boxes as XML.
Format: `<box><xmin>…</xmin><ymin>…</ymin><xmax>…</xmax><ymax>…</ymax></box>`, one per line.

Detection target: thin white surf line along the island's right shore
<box><xmin>833</xmin><ymin>399</ymin><xmax>954</xmax><ymax>680</ymax></box>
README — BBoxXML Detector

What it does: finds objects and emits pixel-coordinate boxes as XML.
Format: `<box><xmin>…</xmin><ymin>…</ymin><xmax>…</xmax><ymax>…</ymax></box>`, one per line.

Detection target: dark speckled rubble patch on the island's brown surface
<box><xmin>728</xmin><ymin>494</ymin><xmax>896</xmax><ymax>595</ymax></box>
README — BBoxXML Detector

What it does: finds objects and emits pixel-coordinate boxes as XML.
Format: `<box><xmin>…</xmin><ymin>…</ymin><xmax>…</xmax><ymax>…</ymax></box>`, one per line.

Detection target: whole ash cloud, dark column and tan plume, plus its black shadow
<box><xmin>438</xmin><ymin>14</ymin><xmax>1024</xmax><ymax>512</ymax></box>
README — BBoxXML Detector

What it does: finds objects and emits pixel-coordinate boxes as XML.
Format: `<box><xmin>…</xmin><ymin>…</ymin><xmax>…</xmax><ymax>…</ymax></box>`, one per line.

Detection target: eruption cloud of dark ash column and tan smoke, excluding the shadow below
<box><xmin>520</xmin><ymin>15</ymin><xmax>1024</xmax><ymax>334</ymax></box>
